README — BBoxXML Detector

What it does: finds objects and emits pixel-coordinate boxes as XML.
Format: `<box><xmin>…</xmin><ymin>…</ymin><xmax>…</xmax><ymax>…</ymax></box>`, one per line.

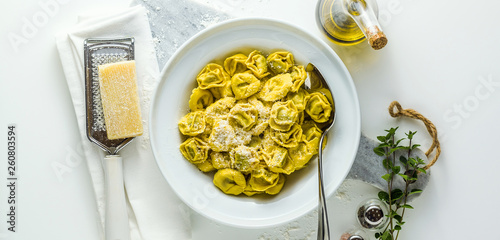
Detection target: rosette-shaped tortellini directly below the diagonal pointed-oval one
<box><xmin>269</xmin><ymin>101</ymin><xmax>299</xmax><ymax>131</ymax></box>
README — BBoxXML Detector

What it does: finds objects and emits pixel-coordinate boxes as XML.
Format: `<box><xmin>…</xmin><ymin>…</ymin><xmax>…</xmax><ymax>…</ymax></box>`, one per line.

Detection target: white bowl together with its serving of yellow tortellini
<box><xmin>149</xmin><ymin>18</ymin><xmax>360</xmax><ymax>228</ymax></box>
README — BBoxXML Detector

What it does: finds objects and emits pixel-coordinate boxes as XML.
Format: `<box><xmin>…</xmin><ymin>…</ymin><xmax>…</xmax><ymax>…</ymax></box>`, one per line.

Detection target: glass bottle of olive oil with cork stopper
<box><xmin>316</xmin><ymin>0</ymin><xmax>387</xmax><ymax>49</ymax></box>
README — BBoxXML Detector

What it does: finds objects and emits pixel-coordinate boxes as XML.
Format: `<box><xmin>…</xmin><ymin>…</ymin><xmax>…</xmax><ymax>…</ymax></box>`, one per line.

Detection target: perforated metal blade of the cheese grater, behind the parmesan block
<box><xmin>84</xmin><ymin>38</ymin><xmax>134</xmax><ymax>155</ymax></box>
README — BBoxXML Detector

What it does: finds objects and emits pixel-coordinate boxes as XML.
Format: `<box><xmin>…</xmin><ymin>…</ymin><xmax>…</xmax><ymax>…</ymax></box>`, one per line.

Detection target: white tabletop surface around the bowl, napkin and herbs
<box><xmin>0</xmin><ymin>0</ymin><xmax>500</xmax><ymax>240</ymax></box>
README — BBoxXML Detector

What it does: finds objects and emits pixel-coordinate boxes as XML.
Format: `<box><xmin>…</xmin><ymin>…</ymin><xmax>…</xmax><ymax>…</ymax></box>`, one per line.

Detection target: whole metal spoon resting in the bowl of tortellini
<box><xmin>304</xmin><ymin>63</ymin><xmax>336</xmax><ymax>240</ymax></box>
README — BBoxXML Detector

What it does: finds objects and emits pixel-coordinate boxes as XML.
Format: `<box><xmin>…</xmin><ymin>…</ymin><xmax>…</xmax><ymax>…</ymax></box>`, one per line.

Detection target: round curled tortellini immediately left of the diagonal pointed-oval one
<box><xmin>231</xmin><ymin>72</ymin><xmax>260</xmax><ymax>99</ymax></box>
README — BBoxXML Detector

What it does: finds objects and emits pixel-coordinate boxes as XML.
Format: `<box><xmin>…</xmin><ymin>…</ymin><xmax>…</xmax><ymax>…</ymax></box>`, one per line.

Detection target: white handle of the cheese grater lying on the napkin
<box><xmin>104</xmin><ymin>155</ymin><xmax>130</xmax><ymax>240</ymax></box>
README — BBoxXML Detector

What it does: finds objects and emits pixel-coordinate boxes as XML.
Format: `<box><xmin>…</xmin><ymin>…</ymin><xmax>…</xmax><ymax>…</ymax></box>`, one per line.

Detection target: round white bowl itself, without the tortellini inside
<box><xmin>150</xmin><ymin>18</ymin><xmax>360</xmax><ymax>228</ymax></box>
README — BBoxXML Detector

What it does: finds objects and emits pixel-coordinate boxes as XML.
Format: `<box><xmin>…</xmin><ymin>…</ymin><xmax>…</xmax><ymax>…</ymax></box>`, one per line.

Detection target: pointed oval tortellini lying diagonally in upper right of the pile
<box><xmin>259</xmin><ymin>73</ymin><xmax>292</xmax><ymax>102</ymax></box>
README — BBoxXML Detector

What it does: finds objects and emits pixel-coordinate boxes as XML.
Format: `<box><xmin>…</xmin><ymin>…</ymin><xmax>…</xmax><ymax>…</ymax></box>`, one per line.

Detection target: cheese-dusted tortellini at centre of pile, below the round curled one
<box><xmin>229</xmin><ymin>103</ymin><xmax>259</xmax><ymax>131</ymax></box>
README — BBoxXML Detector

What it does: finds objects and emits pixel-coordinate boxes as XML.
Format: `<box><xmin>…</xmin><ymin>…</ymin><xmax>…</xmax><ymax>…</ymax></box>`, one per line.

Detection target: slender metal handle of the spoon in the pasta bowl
<box><xmin>318</xmin><ymin>133</ymin><xmax>330</xmax><ymax>240</ymax></box>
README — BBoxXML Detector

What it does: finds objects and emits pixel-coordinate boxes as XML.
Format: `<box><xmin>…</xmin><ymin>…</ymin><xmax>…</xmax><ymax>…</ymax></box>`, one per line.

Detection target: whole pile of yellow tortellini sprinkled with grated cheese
<box><xmin>178</xmin><ymin>50</ymin><xmax>334</xmax><ymax>196</ymax></box>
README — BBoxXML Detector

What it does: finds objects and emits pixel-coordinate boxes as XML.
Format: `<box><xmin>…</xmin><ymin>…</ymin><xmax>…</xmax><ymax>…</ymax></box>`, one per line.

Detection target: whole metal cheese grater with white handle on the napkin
<box><xmin>84</xmin><ymin>38</ymin><xmax>134</xmax><ymax>240</ymax></box>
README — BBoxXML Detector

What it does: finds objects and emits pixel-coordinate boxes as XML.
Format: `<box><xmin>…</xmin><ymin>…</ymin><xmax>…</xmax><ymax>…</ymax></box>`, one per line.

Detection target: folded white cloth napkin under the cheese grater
<box><xmin>56</xmin><ymin>6</ymin><xmax>191</xmax><ymax>239</ymax></box>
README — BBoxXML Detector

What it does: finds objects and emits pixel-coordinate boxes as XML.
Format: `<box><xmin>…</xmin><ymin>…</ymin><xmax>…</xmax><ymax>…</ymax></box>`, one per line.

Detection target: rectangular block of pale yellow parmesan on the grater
<box><xmin>99</xmin><ymin>61</ymin><xmax>143</xmax><ymax>139</ymax></box>
